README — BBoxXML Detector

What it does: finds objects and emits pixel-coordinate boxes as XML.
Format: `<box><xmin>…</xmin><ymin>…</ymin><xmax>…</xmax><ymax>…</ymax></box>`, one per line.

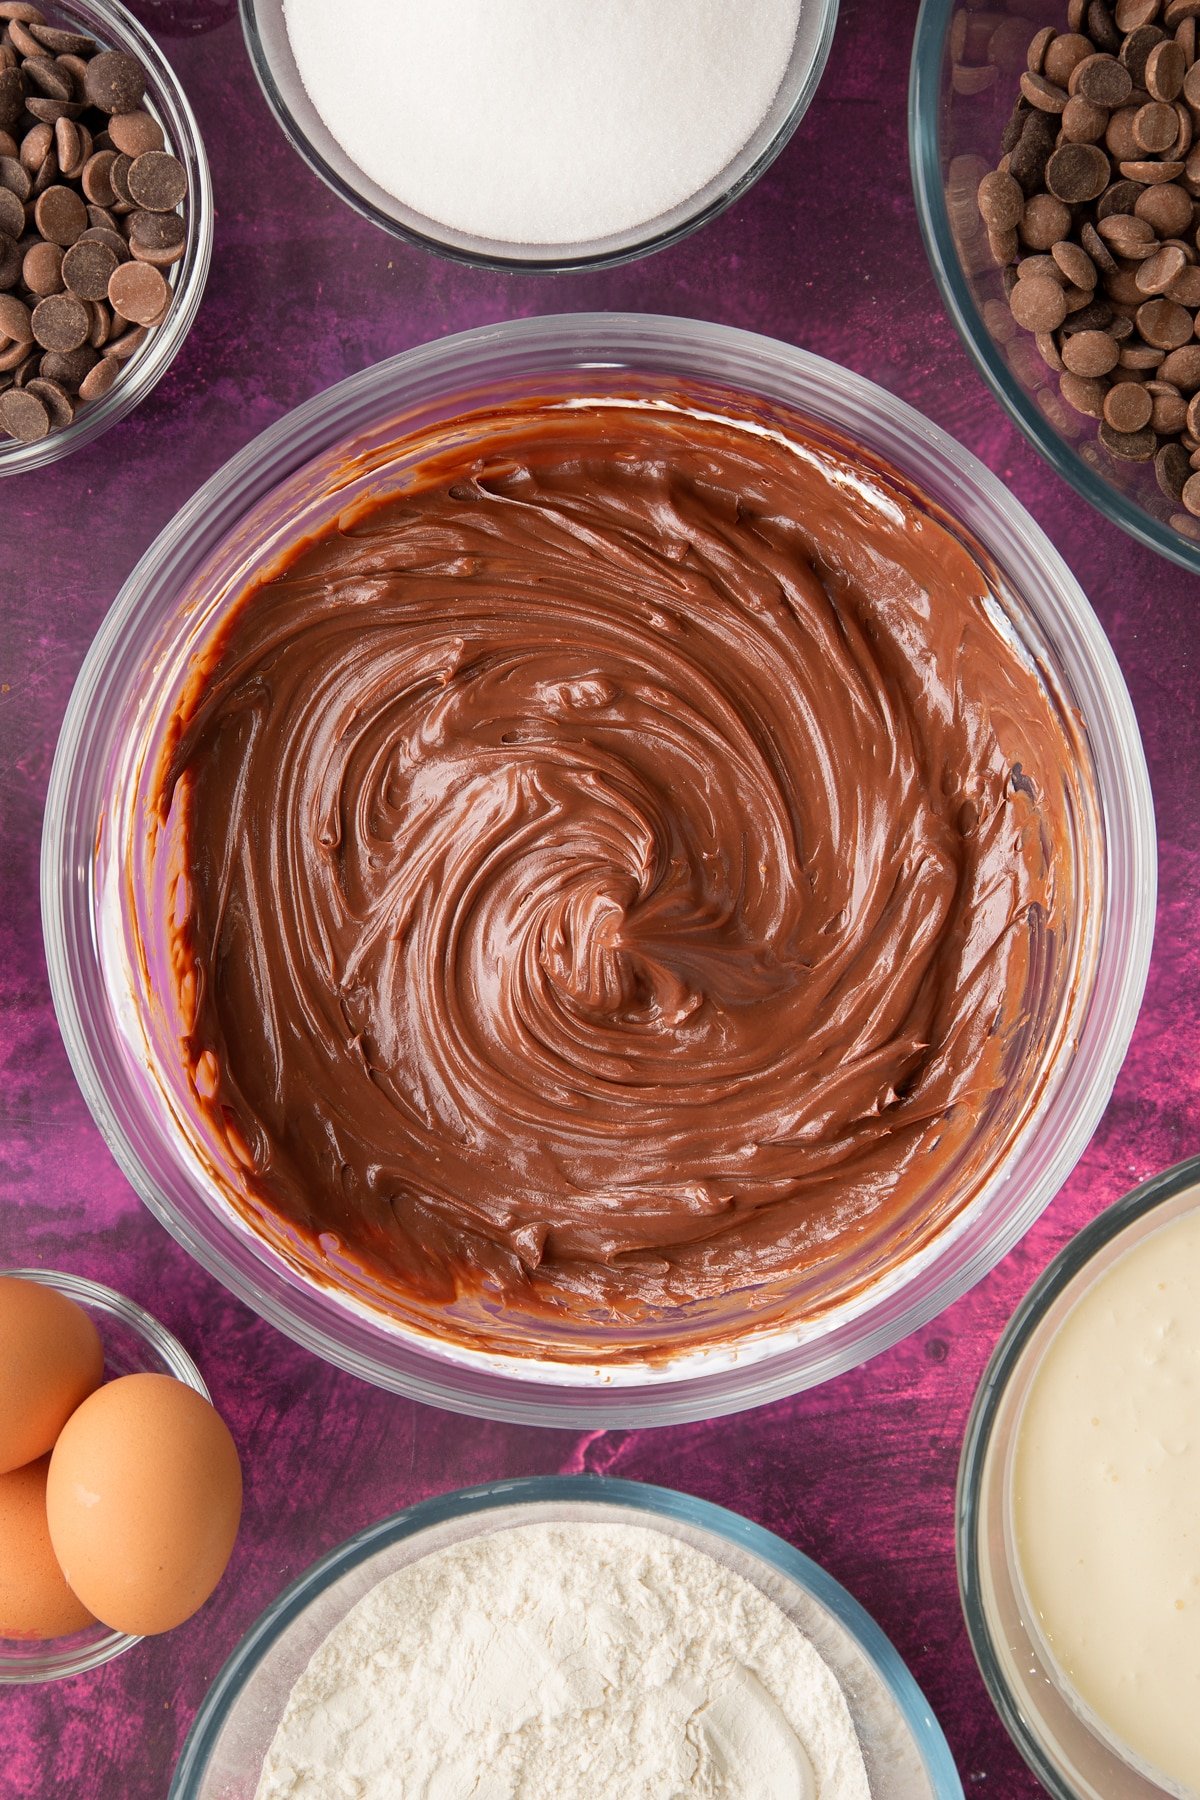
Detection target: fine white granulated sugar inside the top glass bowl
<box><xmin>284</xmin><ymin>0</ymin><xmax>802</xmax><ymax>245</ymax></box>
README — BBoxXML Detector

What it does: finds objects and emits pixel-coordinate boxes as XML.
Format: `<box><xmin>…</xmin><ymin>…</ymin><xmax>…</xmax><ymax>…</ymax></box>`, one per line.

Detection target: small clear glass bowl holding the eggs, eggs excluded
<box><xmin>0</xmin><ymin>1269</ymin><xmax>210</xmax><ymax>1687</ymax></box>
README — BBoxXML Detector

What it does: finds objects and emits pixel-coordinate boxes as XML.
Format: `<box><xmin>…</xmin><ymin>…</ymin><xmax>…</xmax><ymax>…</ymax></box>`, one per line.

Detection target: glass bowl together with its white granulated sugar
<box><xmin>241</xmin><ymin>0</ymin><xmax>838</xmax><ymax>270</ymax></box>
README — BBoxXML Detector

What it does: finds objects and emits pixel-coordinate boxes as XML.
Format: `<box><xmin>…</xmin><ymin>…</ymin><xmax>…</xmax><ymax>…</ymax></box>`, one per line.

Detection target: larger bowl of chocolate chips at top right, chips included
<box><xmin>928</xmin><ymin>0</ymin><xmax>1200</xmax><ymax>572</ymax></box>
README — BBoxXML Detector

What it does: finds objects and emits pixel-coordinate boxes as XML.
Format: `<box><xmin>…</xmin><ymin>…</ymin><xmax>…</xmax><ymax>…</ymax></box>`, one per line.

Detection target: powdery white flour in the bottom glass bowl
<box><xmin>257</xmin><ymin>1523</ymin><xmax>871</xmax><ymax>1800</ymax></box>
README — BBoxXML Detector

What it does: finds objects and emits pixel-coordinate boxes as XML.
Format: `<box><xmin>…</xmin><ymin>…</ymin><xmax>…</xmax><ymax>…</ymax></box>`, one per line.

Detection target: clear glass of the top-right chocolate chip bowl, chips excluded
<box><xmin>909</xmin><ymin>0</ymin><xmax>1200</xmax><ymax>574</ymax></box>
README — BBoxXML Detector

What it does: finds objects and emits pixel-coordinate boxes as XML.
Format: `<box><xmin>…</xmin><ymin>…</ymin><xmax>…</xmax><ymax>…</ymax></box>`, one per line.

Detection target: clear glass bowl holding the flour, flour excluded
<box><xmin>169</xmin><ymin>1476</ymin><xmax>963</xmax><ymax>1800</ymax></box>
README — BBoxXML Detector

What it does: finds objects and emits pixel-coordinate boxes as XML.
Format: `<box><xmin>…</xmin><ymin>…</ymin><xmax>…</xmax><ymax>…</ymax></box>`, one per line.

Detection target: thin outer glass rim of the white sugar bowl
<box><xmin>237</xmin><ymin>0</ymin><xmax>840</xmax><ymax>275</ymax></box>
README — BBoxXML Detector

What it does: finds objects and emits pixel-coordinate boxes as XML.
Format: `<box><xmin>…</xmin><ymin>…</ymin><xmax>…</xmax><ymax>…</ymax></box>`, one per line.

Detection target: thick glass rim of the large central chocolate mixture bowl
<box><xmin>41</xmin><ymin>313</ymin><xmax>1157</xmax><ymax>1426</ymax></box>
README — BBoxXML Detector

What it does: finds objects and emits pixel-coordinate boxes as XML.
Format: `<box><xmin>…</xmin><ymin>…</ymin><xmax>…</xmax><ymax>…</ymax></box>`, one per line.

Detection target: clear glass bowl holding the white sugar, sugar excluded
<box><xmin>241</xmin><ymin>0</ymin><xmax>838</xmax><ymax>274</ymax></box>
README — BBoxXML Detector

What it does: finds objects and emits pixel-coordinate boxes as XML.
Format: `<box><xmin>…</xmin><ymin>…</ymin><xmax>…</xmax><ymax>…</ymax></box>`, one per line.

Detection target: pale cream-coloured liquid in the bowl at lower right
<box><xmin>1013</xmin><ymin>1210</ymin><xmax>1200</xmax><ymax>1791</ymax></box>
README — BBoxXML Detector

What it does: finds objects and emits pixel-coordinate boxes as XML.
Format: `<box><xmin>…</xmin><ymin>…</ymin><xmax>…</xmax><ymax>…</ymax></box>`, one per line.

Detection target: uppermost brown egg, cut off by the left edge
<box><xmin>0</xmin><ymin>1274</ymin><xmax>104</xmax><ymax>1472</ymax></box>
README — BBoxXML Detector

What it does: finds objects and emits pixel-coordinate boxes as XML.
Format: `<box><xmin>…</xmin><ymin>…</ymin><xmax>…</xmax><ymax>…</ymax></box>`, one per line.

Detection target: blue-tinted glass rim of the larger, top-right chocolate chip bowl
<box><xmin>909</xmin><ymin>0</ymin><xmax>1200</xmax><ymax>574</ymax></box>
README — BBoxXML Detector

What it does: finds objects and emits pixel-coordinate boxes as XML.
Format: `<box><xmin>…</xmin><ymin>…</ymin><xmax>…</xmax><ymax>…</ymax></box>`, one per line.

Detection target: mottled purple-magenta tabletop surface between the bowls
<box><xmin>0</xmin><ymin>0</ymin><xmax>1200</xmax><ymax>1800</ymax></box>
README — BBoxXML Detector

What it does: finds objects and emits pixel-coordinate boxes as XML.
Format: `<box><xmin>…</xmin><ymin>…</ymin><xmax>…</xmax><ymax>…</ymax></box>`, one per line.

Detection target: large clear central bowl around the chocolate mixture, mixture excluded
<box><xmin>41</xmin><ymin>315</ymin><xmax>1155</xmax><ymax>1426</ymax></box>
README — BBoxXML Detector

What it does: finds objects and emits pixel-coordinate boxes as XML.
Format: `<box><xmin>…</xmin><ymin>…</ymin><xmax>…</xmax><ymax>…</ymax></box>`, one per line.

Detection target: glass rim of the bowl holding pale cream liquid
<box><xmin>954</xmin><ymin>1156</ymin><xmax>1200</xmax><ymax>1800</ymax></box>
